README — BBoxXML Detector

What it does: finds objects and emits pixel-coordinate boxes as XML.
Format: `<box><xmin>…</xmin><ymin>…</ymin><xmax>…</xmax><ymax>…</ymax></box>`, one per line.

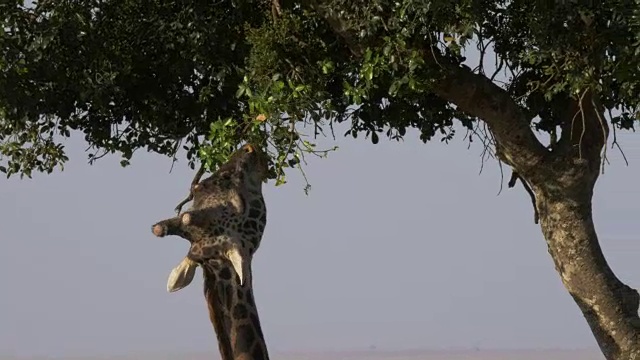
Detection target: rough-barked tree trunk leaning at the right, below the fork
<box><xmin>531</xmin><ymin>159</ymin><xmax>640</xmax><ymax>360</ymax></box>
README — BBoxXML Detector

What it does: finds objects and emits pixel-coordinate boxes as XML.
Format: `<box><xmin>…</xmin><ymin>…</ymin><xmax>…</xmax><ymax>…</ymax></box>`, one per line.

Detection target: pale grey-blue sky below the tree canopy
<box><xmin>0</xmin><ymin>122</ymin><xmax>640</xmax><ymax>357</ymax></box>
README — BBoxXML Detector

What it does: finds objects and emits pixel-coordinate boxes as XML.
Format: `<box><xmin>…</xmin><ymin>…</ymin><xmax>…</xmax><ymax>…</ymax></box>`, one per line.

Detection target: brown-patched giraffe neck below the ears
<box><xmin>203</xmin><ymin>263</ymin><xmax>269</xmax><ymax>360</ymax></box>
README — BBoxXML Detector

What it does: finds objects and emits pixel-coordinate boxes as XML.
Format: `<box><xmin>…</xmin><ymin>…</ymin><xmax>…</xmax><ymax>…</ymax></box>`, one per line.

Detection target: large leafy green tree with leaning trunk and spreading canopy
<box><xmin>0</xmin><ymin>0</ymin><xmax>640</xmax><ymax>360</ymax></box>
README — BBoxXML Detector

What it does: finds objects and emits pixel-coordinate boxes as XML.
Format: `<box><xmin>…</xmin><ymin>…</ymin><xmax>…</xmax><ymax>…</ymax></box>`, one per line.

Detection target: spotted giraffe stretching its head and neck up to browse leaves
<box><xmin>152</xmin><ymin>144</ymin><xmax>269</xmax><ymax>360</ymax></box>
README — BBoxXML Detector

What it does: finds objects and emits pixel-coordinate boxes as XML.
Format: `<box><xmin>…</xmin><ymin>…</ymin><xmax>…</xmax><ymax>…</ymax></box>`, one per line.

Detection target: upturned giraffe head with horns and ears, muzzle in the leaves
<box><xmin>153</xmin><ymin>144</ymin><xmax>268</xmax><ymax>292</ymax></box>
